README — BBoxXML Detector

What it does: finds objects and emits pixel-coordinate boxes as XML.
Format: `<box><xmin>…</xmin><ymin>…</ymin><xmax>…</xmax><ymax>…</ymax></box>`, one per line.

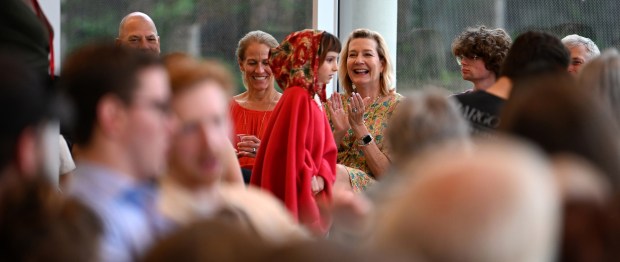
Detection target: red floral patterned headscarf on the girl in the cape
<box><xmin>269</xmin><ymin>29</ymin><xmax>326</xmax><ymax>102</ymax></box>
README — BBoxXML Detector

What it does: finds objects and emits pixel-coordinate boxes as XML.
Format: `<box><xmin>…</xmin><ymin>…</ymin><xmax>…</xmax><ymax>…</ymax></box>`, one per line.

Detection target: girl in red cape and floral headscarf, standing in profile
<box><xmin>251</xmin><ymin>30</ymin><xmax>341</xmax><ymax>235</ymax></box>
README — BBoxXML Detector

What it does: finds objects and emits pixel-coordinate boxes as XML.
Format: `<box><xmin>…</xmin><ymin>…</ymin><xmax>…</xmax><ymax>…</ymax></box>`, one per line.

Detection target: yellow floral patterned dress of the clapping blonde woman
<box><xmin>325</xmin><ymin>93</ymin><xmax>403</xmax><ymax>192</ymax></box>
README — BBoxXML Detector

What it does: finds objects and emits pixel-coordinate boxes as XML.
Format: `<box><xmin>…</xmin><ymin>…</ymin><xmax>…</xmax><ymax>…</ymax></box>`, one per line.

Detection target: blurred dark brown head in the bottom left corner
<box><xmin>0</xmin><ymin>179</ymin><xmax>103</xmax><ymax>261</ymax></box>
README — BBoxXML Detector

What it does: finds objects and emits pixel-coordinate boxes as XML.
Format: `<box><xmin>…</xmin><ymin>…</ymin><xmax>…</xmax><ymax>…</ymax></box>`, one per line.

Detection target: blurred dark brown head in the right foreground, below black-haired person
<box><xmin>499</xmin><ymin>71</ymin><xmax>620</xmax><ymax>190</ymax></box>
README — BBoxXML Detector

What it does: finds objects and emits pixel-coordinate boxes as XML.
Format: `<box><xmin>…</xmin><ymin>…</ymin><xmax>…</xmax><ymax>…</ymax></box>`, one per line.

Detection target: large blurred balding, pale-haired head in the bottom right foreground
<box><xmin>374</xmin><ymin>139</ymin><xmax>560</xmax><ymax>262</ymax></box>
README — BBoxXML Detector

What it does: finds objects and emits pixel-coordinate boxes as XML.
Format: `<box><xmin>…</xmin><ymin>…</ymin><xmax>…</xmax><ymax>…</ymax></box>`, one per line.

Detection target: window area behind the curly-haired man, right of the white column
<box><xmin>397</xmin><ymin>0</ymin><xmax>620</xmax><ymax>92</ymax></box>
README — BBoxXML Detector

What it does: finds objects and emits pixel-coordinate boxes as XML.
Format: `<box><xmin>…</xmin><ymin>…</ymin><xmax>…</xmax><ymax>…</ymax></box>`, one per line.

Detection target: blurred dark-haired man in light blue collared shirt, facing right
<box><xmin>61</xmin><ymin>44</ymin><xmax>172</xmax><ymax>261</ymax></box>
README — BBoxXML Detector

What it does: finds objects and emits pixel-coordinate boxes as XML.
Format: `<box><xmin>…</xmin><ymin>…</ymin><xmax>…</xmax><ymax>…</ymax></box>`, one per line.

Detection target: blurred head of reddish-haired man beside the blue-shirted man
<box><xmin>164</xmin><ymin>53</ymin><xmax>236</xmax><ymax>188</ymax></box>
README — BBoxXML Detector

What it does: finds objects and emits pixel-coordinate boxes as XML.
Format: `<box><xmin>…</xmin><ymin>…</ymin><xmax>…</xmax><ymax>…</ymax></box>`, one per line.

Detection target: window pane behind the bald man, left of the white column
<box><xmin>61</xmin><ymin>0</ymin><xmax>312</xmax><ymax>93</ymax></box>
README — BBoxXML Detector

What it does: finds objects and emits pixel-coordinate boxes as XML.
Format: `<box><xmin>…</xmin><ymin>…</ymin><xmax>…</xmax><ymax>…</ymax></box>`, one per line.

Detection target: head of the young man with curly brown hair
<box><xmin>452</xmin><ymin>26</ymin><xmax>512</xmax><ymax>90</ymax></box>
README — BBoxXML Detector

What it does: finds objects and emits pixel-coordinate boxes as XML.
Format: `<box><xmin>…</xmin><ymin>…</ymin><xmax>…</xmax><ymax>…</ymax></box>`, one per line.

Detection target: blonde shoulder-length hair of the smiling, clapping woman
<box><xmin>338</xmin><ymin>28</ymin><xmax>394</xmax><ymax>96</ymax></box>
